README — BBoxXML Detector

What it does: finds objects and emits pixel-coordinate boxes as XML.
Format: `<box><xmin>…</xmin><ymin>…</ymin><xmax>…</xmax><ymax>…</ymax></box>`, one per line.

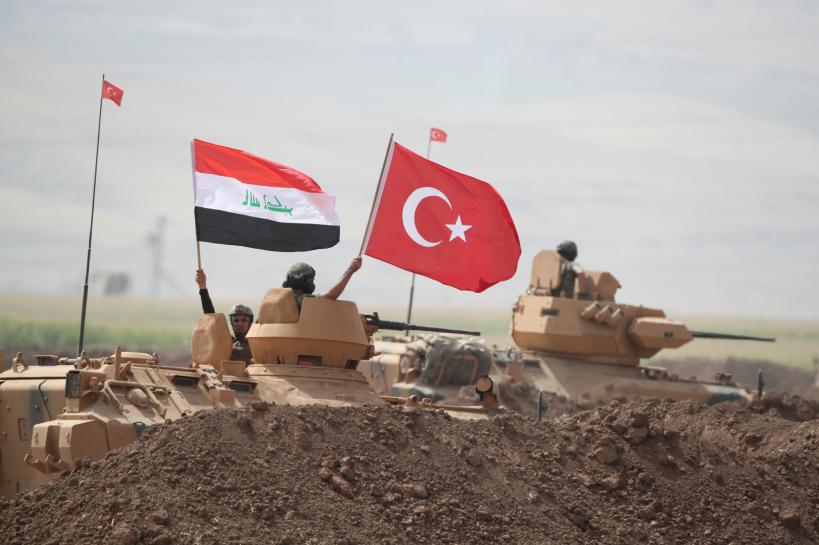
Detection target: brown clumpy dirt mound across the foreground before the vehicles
<box><xmin>0</xmin><ymin>397</ymin><xmax>819</xmax><ymax>545</ymax></box>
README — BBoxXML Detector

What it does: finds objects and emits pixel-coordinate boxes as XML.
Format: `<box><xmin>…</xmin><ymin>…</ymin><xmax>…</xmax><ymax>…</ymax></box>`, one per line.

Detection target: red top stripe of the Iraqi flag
<box><xmin>193</xmin><ymin>140</ymin><xmax>323</xmax><ymax>193</ymax></box>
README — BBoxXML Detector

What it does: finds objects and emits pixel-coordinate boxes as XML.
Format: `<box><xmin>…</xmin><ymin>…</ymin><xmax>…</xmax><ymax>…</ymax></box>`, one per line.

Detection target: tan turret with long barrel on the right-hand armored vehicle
<box><xmin>512</xmin><ymin>250</ymin><xmax>774</xmax><ymax>366</ymax></box>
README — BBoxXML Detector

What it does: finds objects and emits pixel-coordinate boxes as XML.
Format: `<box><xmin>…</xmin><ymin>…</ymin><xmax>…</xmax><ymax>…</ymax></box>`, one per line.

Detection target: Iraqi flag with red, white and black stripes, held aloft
<box><xmin>191</xmin><ymin>140</ymin><xmax>340</xmax><ymax>252</ymax></box>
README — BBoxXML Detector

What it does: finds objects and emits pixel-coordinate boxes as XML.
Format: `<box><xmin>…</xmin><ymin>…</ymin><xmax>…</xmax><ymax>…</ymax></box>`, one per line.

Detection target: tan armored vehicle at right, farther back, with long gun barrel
<box><xmin>511</xmin><ymin>250</ymin><xmax>774</xmax><ymax>403</ymax></box>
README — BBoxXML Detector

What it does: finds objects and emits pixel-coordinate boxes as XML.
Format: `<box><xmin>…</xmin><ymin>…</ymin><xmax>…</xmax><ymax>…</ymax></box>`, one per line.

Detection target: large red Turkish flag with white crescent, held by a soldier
<box><xmin>364</xmin><ymin>143</ymin><xmax>520</xmax><ymax>292</ymax></box>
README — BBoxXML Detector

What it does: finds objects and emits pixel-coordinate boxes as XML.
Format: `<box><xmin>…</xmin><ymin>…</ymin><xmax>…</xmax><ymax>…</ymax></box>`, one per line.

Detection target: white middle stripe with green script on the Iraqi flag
<box><xmin>193</xmin><ymin>172</ymin><xmax>339</xmax><ymax>225</ymax></box>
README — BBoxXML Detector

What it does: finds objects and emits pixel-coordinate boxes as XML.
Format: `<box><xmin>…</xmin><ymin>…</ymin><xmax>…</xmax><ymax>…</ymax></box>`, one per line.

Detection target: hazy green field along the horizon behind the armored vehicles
<box><xmin>0</xmin><ymin>294</ymin><xmax>819</xmax><ymax>369</ymax></box>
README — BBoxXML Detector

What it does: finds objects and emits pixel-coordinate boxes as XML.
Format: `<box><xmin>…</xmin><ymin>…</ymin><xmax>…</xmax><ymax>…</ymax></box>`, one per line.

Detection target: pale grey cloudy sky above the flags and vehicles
<box><xmin>0</xmin><ymin>0</ymin><xmax>819</xmax><ymax>319</ymax></box>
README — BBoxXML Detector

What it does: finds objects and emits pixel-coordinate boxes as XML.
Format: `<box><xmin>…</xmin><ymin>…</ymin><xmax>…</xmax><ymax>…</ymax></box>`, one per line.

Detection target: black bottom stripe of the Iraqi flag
<box><xmin>194</xmin><ymin>206</ymin><xmax>340</xmax><ymax>252</ymax></box>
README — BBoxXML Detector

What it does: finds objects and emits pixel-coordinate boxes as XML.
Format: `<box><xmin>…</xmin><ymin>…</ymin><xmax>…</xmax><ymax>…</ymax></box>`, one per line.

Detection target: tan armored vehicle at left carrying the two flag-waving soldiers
<box><xmin>0</xmin><ymin>289</ymin><xmax>497</xmax><ymax>496</ymax></box>
